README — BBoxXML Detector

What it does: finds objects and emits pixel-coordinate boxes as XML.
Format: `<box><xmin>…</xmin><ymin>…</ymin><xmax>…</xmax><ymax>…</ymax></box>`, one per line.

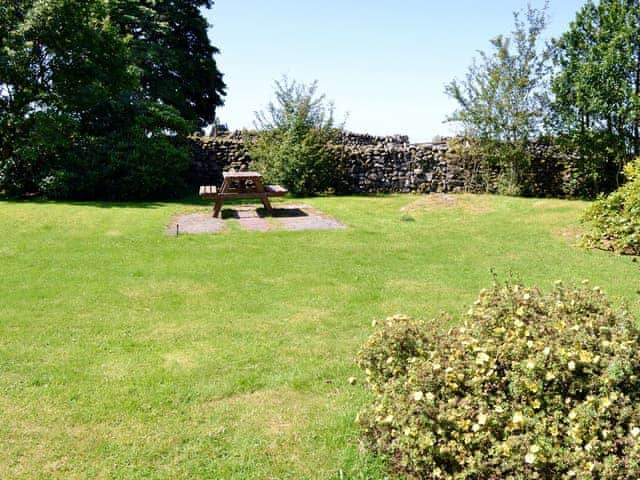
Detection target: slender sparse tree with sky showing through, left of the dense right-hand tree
<box><xmin>445</xmin><ymin>6</ymin><xmax>549</xmax><ymax>193</ymax></box>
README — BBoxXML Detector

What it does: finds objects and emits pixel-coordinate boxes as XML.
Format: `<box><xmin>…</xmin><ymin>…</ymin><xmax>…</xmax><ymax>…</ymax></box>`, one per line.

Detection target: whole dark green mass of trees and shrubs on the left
<box><xmin>0</xmin><ymin>0</ymin><xmax>223</xmax><ymax>199</ymax></box>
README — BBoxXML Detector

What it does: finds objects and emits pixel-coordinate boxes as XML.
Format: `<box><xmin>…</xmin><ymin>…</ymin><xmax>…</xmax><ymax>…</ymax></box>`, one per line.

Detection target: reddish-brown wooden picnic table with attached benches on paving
<box><xmin>200</xmin><ymin>172</ymin><xmax>287</xmax><ymax>217</ymax></box>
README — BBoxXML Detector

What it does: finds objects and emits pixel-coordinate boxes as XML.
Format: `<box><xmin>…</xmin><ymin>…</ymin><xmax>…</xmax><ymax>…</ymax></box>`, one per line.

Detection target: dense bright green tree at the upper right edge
<box><xmin>552</xmin><ymin>0</ymin><xmax>640</xmax><ymax>172</ymax></box>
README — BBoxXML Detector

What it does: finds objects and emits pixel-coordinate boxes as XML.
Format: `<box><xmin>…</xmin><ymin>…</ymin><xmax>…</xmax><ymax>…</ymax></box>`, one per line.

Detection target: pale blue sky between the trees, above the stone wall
<box><xmin>205</xmin><ymin>0</ymin><xmax>585</xmax><ymax>141</ymax></box>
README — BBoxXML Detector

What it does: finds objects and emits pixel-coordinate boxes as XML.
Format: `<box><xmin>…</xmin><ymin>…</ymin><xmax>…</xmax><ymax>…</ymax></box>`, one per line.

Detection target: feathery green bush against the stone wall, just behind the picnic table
<box><xmin>250</xmin><ymin>77</ymin><xmax>342</xmax><ymax>195</ymax></box>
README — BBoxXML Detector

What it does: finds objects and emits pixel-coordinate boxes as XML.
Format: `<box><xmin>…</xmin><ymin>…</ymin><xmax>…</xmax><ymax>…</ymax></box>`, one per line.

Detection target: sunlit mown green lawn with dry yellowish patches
<box><xmin>0</xmin><ymin>196</ymin><xmax>640</xmax><ymax>479</ymax></box>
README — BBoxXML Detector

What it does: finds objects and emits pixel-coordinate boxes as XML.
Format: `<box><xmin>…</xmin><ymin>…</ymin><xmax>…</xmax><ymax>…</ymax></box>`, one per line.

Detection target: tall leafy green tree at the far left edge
<box><xmin>0</xmin><ymin>0</ymin><xmax>142</xmax><ymax>197</ymax></box>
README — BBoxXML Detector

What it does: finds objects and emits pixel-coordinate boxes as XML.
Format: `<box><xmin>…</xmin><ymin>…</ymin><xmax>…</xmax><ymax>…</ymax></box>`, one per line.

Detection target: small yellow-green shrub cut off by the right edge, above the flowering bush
<box><xmin>583</xmin><ymin>158</ymin><xmax>640</xmax><ymax>255</ymax></box>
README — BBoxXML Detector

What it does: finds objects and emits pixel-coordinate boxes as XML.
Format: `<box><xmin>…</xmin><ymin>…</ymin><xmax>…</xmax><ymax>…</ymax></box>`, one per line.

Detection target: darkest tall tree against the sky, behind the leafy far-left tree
<box><xmin>109</xmin><ymin>0</ymin><xmax>226</xmax><ymax>127</ymax></box>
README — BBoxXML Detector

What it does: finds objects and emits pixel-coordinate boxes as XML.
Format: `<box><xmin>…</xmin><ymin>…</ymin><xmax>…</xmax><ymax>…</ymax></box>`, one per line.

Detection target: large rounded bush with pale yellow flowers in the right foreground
<box><xmin>358</xmin><ymin>284</ymin><xmax>640</xmax><ymax>480</ymax></box>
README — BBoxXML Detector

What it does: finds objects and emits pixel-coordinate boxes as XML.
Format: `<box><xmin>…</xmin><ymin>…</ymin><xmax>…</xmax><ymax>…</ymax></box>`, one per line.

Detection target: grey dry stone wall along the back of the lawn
<box><xmin>191</xmin><ymin>131</ymin><xmax>597</xmax><ymax>197</ymax></box>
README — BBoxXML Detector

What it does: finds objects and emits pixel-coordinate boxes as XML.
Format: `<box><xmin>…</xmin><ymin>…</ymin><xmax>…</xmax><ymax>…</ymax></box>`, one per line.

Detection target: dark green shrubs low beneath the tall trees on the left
<box><xmin>0</xmin><ymin>103</ymin><xmax>190</xmax><ymax>200</ymax></box>
